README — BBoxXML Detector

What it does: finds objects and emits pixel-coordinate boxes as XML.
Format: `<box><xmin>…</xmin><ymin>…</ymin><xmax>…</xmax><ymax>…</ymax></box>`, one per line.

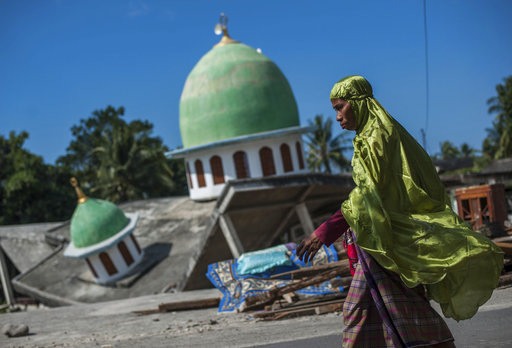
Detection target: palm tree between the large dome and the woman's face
<box><xmin>306</xmin><ymin>115</ymin><xmax>350</xmax><ymax>173</ymax></box>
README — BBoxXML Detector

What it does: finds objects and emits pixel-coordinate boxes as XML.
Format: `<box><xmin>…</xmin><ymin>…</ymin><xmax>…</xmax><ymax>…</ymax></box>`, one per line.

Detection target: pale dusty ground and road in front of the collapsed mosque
<box><xmin>0</xmin><ymin>288</ymin><xmax>512</xmax><ymax>348</ymax></box>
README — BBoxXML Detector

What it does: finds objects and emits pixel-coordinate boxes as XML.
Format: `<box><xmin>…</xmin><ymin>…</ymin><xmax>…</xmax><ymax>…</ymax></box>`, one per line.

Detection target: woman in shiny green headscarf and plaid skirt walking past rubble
<box><xmin>297</xmin><ymin>76</ymin><xmax>503</xmax><ymax>347</ymax></box>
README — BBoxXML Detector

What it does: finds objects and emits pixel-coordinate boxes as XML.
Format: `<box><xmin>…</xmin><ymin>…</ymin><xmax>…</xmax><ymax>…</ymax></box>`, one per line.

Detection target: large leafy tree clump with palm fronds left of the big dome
<box><xmin>58</xmin><ymin>106</ymin><xmax>186</xmax><ymax>203</ymax></box>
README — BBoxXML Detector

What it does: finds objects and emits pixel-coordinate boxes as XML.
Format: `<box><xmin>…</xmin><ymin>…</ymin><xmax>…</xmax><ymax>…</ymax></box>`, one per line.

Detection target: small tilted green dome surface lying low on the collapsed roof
<box><xmin>71</xmin><ymin>198</ymin><xmax>130</xmax><ymax>248</ymax></box>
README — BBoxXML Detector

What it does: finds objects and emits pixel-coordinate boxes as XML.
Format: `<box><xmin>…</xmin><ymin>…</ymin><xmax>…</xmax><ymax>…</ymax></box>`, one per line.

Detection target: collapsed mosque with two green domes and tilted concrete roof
<box><xmin>0</xmin><ymin>16</ymin><xmax>353</xmax><ymax>306</ymax></box>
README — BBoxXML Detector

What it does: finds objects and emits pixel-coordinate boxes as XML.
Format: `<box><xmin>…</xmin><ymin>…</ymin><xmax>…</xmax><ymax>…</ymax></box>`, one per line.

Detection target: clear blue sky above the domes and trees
<box><xmin>0</xmin><ymin>0</ymin><xmax>512</xmax><ymax>163</ymax></box>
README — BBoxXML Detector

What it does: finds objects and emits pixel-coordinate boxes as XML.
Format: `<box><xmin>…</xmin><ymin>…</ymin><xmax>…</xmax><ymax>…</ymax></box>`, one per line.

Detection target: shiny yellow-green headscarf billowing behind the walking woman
<box><xmin>330</xmin><ymin>76</ymin><xmax>503</xmax><ymax>320</ymax></box>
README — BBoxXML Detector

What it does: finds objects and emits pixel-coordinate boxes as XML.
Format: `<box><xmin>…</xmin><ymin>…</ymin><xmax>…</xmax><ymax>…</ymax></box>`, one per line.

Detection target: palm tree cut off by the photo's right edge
<box><xmin>482</xmin><ymin>75</ymin><xmax>512</xmax><ymax>159</ymax></box>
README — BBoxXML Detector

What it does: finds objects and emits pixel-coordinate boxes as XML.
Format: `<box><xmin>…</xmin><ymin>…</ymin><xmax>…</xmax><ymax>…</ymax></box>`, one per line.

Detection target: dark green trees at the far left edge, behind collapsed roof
<box><xmin>0</xmin><ymin>132</ymin><xmax>76</xmax><ymax>225</ymax></box>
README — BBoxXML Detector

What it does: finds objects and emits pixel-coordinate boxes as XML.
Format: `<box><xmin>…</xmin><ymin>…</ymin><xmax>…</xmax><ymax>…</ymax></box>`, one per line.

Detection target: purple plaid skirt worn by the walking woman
<box><xmin>342</xmin><ymin>233</ymin><xmax>453</xmax><ymax>348</ymax></box>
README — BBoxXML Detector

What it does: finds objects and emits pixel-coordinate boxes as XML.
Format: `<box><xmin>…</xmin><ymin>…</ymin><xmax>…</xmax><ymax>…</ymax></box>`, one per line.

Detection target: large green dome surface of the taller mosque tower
<box><xmin>180</xmin><ymin>43</ymin><xmax>299</xmax><ymax>148</ymax></box>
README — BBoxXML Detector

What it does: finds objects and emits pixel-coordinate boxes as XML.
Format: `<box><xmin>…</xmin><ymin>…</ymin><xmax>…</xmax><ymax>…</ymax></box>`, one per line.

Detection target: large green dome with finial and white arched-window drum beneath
<box><xmin>167</xmin><ymin>16</ymin><xmax>311</xmax><ymax>200</ymax></box>
